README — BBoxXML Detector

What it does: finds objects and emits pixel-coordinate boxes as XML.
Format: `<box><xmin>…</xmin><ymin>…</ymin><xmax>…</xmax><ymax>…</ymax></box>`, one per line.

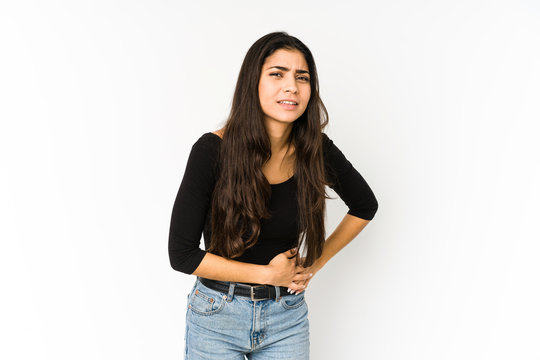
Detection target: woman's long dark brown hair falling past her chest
<box><xmin>208</xmin><ymin>32</ymin><xmax>328</xmax><ymax>267</ymax></box>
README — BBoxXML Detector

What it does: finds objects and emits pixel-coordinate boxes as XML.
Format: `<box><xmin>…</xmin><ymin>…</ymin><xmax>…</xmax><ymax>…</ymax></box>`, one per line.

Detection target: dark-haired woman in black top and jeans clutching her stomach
<box><xmin>169</xmin><ymin>32</ymin><xmax>378</xmax><ymax>360</ymax></box>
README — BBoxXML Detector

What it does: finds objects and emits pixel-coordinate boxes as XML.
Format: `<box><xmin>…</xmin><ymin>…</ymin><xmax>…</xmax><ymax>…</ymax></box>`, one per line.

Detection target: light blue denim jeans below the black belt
<box><xmin>184</xmin><ymin>277</ymin><xmax>309</xmax><ymax>360</ymax></box>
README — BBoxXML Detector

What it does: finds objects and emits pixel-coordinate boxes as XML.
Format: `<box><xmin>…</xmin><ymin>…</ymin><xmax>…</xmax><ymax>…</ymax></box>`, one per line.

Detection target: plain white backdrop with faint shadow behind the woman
<box><xmin>0</xmin><ymin>0</ymin><xmax>540</xmax><ymax>360</ymax></box>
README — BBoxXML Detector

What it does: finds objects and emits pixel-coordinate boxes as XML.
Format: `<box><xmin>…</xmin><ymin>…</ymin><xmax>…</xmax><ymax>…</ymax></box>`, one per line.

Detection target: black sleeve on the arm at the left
<box><xmin>169</xmin><ymin>137</ymin><xmax>217</xmax><ymax>274</ymax></box>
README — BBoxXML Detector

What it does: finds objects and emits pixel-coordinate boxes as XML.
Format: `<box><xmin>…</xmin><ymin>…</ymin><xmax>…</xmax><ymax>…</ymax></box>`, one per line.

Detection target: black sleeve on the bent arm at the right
<box><xmin>323</xmin><ymin>133</ymin><xmax>379</xmax><ymax>220</ymax></box>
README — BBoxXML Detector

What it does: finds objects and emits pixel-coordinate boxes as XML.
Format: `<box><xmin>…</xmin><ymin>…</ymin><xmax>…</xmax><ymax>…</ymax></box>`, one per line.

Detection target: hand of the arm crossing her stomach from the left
<box><xmin>267</xmin><ymin>248</ymin><xmax>311</xmax><ymax>291</ymax></box>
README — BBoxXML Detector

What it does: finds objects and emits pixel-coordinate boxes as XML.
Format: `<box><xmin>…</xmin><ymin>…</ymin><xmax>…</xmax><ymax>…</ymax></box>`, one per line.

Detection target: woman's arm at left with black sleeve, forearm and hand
<box><xmin>169</xmin><ymin>137</ymin><xmax>307</xmax><ymax>289</ymax></box>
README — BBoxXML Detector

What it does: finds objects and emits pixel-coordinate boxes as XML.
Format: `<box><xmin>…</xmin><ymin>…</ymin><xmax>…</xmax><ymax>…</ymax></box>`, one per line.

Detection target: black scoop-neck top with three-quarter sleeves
<box><xmin>169</xmin><ymin>132</ymin><xmax>378</xmax><ymax>274</ymax></box>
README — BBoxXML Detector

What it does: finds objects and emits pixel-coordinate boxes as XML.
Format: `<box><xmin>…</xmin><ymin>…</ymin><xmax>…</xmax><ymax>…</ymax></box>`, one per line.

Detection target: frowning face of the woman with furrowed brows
<box><xmin>259</xmin><ymin>49</ymin><xmax>311</xmax><ymax>123</ymax></box>
